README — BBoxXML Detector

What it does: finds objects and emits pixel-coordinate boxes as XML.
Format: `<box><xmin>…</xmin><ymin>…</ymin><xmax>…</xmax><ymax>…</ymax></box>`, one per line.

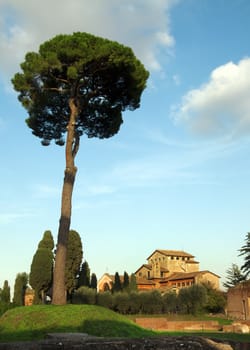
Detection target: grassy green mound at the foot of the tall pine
<box><xmin>0</xmin><ymin>305</ymin><xmax>156</xmax><ymax>342</ymax></box>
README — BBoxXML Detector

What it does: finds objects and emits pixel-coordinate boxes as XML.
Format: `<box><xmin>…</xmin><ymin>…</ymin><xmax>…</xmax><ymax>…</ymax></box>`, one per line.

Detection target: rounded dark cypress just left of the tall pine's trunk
<box><xmin>29</xmin><ymin>231</ymin><xmax>54</xmax><ymax>304</ymax></box>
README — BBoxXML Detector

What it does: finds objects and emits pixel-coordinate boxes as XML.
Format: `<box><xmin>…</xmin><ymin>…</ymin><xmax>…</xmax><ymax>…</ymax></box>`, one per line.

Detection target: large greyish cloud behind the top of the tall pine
<box><xmin>0</xmin><ymin>0</ymin><xmax>177</xmax><ymax>83</ymax></box>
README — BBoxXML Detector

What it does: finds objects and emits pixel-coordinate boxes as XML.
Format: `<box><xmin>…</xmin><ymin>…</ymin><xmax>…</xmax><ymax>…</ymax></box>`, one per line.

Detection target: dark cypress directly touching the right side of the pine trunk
<box><xmin>65</xmin><ymin>230</ymin><xmax>83</xmax><ymax>299</ymax></box>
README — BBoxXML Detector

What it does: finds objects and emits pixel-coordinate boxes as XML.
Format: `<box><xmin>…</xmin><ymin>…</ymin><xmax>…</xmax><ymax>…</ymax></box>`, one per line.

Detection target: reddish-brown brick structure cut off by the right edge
<box><xmin>227</xmin><ymin>280</ymin><xmax>250</xmax><ymax>320</ymax></box>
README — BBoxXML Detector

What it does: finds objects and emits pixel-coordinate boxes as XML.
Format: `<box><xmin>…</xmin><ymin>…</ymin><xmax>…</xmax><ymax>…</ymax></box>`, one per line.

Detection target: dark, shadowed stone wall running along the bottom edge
<box><xmin>0</xmin><ymin>333</ymin><xmax>240</xmax><ymax>350</ymax></box>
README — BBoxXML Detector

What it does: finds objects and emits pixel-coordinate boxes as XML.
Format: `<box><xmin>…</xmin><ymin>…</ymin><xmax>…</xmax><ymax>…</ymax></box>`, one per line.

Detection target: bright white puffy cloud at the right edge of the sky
<box><xmin>172</xmin><ymin>58</ymin><xmax>250</xmax><ymax>137</ymax></box>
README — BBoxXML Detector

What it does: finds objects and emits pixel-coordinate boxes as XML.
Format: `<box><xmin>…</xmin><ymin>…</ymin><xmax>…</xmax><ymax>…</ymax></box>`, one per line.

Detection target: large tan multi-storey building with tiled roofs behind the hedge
<box><xmin>135</xmin><ymin>249</ymin><xmax>220</xmax><ymax>291</ymax></box>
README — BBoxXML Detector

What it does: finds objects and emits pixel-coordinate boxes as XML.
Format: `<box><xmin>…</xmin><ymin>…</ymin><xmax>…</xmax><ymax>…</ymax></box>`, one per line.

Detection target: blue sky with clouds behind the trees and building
<box><xmin>0</xmin><ymin>0</ymin><xmax>250</xmax><ymax>294</ymax></box>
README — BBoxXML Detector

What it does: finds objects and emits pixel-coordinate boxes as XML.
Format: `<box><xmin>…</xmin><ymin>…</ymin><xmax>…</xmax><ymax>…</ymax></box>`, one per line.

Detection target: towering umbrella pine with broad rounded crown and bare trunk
<box><xmin>12</xmin><ymin>33</ymin><xmax>148</xmax><ymax>304</ymax></box>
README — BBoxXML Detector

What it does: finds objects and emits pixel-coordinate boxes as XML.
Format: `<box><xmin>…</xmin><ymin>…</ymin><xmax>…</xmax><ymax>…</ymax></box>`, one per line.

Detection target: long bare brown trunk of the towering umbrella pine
<box><xmin>52</xmin><ymin>98</ymin><xmax>79</xmax><ymax>305</ymax></box>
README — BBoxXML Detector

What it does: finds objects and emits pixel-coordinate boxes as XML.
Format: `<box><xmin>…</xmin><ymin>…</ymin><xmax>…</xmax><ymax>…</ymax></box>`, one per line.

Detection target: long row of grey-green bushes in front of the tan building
<box><xmin>73</xmin><ymin>285</ymin><xmax>226</xmax><ymax>315</ymax></box>
